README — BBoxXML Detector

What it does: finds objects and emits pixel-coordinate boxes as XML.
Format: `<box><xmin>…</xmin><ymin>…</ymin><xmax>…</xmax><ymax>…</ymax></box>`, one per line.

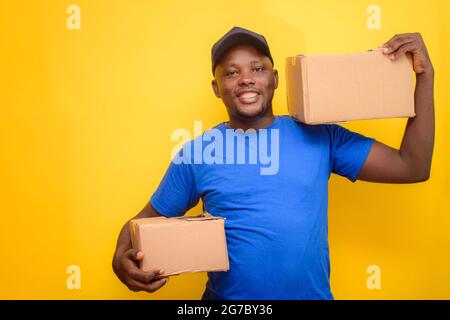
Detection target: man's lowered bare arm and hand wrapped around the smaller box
<box><xmin>112</xmin><ymin>202</ymin><xmax>169</xmax><ymax>292</ymax></box>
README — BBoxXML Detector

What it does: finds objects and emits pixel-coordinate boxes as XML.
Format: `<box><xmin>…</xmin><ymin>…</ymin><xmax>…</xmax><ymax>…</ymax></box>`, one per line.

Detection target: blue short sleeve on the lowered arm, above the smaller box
<box><xmin>150</xmin><ymin>148</ymin><xmax>200</xmax><ymax>217</ymax></box>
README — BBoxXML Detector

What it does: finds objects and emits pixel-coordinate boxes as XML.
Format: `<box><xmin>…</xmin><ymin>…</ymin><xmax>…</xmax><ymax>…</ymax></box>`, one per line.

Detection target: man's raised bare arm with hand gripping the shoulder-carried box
<box><xmin>358</xmin><ymin>33</ymin><xmax>434</xmax><ymax>183</ymax></box>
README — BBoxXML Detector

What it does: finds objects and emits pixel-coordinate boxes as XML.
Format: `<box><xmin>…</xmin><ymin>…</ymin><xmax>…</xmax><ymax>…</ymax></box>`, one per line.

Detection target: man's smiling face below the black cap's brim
<box><xmin>212</xmin><ymin>45</ymin><xmax>278</xmax><ymax>120</ymax></box>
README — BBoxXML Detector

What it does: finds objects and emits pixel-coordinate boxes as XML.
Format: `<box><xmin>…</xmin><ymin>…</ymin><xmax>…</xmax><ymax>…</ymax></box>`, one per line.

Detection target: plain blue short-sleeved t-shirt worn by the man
<box><xmin>151</xmin><ymin>116</ymin><xmax>374</xmax><ymax>299</ymax></box>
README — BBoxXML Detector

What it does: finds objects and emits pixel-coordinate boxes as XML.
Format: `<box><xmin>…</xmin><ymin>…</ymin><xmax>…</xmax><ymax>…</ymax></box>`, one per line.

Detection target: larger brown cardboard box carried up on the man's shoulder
<box><xmin>286</xmin><ymin>48</ymin><xmax>415</xmax><ymax>124</ymax></box>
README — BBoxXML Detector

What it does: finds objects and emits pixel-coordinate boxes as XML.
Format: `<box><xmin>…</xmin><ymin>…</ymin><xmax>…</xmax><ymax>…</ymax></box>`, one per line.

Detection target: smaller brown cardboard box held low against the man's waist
<box><xmin>130</xmin><ymin>213</ymin><xmax>229</xmax><ymax>276</ymax></box>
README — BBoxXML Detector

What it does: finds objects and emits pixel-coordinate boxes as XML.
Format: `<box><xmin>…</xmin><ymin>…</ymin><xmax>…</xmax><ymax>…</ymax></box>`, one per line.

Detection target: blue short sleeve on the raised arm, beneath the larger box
<box><xmin>327</xmin><ymin>124</ymin><xmax>375</xmax><ymax>182</ymax></box>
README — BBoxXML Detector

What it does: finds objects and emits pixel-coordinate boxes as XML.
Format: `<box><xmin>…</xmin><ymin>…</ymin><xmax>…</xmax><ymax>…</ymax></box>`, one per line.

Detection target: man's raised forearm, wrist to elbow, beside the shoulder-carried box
<box><xmin>400</xmin><ymin>70</ymin><xmax>435</xmax><ymax>178</ymax></box>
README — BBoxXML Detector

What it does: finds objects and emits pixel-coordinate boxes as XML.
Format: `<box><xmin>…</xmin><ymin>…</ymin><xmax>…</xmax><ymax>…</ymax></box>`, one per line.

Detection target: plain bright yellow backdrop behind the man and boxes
<box><xmin>0</xmin><ymin>0</ymin><xmax>450</xmax><ymax>299</ymax></box>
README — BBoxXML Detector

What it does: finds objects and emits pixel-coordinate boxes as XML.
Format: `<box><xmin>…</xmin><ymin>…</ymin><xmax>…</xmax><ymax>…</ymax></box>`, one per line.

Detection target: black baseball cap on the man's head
<box><xmin>211</xmin><ymin>27</ymin><xmax>273</xmax><ymax>75</ymax></box>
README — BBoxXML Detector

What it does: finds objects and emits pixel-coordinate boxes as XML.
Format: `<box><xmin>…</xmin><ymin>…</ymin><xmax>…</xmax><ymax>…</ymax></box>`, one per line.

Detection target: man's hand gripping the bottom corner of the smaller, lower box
<box><xmin>113</xmin><ymin>249</ymin><xmax>169</xmax><ymax>292</ymax></box>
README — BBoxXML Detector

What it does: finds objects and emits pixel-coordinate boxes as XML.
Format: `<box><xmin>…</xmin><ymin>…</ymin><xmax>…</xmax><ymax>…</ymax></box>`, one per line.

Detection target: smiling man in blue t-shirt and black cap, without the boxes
<box><xmin>113</xmin><ymin>27</ymin><xmax>434</xmax><ymax>299</ymax></box>
